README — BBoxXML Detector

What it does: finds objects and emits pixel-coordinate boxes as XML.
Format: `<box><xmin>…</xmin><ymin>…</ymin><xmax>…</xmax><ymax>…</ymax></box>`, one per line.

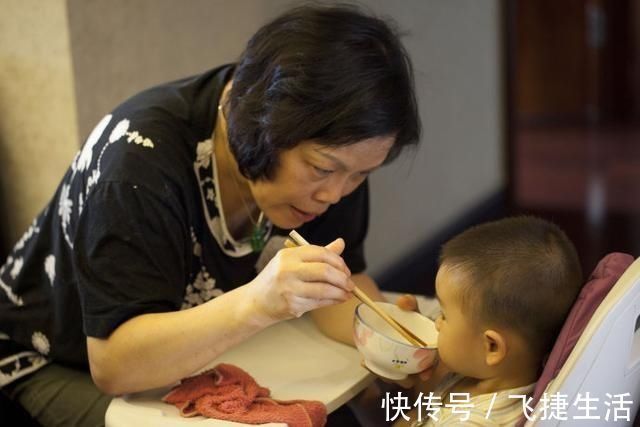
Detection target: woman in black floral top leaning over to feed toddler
<box><xmin>0</xmin><ymin>6</ymin><xmax>420</xmax><ymax>425</ymax></box>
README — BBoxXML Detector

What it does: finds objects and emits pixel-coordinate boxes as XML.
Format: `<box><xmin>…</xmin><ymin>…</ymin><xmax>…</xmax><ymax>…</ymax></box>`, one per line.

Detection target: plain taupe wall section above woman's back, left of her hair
<box><xmin>68</xmin><ymin>0</ymin><xmax>290</xmax><ymax>138</ymax></box>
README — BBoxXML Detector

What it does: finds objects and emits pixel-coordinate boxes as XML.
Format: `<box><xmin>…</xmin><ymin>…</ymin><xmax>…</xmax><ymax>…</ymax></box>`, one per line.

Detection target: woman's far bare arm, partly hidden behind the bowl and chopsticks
<box><xmin>311</xmin><ymin>273</ymin><xmax>385</xmax><ymax>346</ymax></box>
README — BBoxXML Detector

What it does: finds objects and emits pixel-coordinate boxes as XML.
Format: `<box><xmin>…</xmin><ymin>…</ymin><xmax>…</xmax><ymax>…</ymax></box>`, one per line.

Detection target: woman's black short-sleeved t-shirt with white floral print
<box><xmin>0</xmin><ymin>65</ymin><xmax>368</xmax><ymax>386</ymax></box>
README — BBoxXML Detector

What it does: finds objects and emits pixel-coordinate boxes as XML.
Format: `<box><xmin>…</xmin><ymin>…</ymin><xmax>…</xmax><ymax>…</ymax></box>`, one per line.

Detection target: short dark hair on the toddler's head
<box><xmin>440</xmin><ymin>216</ymin><xmax>583</xmax><ymax>356</ymax></box>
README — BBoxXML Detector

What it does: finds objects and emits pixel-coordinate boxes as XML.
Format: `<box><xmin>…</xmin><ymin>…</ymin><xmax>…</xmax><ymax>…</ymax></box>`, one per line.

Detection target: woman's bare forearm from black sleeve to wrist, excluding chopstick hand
<box><xmin>87</xmin><ymin>286</ymin><xmax>264</xmax><ymax>395</ymax></box>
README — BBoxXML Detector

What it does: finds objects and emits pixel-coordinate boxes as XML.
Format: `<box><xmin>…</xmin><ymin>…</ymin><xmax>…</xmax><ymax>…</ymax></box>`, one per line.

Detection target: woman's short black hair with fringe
<box><xmin>224</xmin><ymin>5</ymin><xmax>420</xmax><ymax>180</ymax></box>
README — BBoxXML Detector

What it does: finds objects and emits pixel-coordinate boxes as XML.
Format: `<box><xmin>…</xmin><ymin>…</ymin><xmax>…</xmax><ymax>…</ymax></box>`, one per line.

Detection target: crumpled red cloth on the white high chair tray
<box><xmin>162</xmin><ymin>363</ymin><xmax>327</xmax><ymax>427</ymax></box>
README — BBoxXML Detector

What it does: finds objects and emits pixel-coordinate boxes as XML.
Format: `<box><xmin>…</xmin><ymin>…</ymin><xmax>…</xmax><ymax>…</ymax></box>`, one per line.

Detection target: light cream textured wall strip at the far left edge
<box><xmin>0</xmin><ymin>0</ymin><xmax>78</xmax><ymax>241</ymax></box>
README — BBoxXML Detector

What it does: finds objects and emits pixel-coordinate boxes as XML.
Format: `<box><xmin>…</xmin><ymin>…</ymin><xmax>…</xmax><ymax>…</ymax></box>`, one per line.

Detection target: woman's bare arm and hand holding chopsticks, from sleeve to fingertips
<box><xmin>87</xmin><ymin>239</ymin><xmax>353</xmax><ymax>395</ymax></box>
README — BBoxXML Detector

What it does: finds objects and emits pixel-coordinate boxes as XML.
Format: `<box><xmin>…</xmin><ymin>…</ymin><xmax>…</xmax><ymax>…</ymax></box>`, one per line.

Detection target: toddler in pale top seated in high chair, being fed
<box><xmin>394</xmin><ymin>216</ymin><xmax>583</xmax><ymax>427</ymax></box>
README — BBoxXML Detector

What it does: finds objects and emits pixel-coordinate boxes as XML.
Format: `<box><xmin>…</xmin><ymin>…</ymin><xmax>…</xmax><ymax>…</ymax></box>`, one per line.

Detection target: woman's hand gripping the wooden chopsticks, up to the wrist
<box><xmin>248</xmin><ymin>239</ymin><xmax>354</xmax><ymax>321</ymax></box>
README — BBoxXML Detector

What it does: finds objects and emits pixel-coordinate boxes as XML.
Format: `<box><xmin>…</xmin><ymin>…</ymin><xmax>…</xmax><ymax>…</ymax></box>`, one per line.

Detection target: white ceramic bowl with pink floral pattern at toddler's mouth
<box><xmin>353</xmin><ymin>302</ymin><xmax>438</xmax><ymax>380</ymax></box>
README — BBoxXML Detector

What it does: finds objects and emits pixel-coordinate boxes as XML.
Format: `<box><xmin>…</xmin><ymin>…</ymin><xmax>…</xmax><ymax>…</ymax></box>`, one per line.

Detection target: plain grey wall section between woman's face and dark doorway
<box><xmin>367</xmin><ymin>0</ymin><xmax>506</xmax><ymax>273</ymax></box>
